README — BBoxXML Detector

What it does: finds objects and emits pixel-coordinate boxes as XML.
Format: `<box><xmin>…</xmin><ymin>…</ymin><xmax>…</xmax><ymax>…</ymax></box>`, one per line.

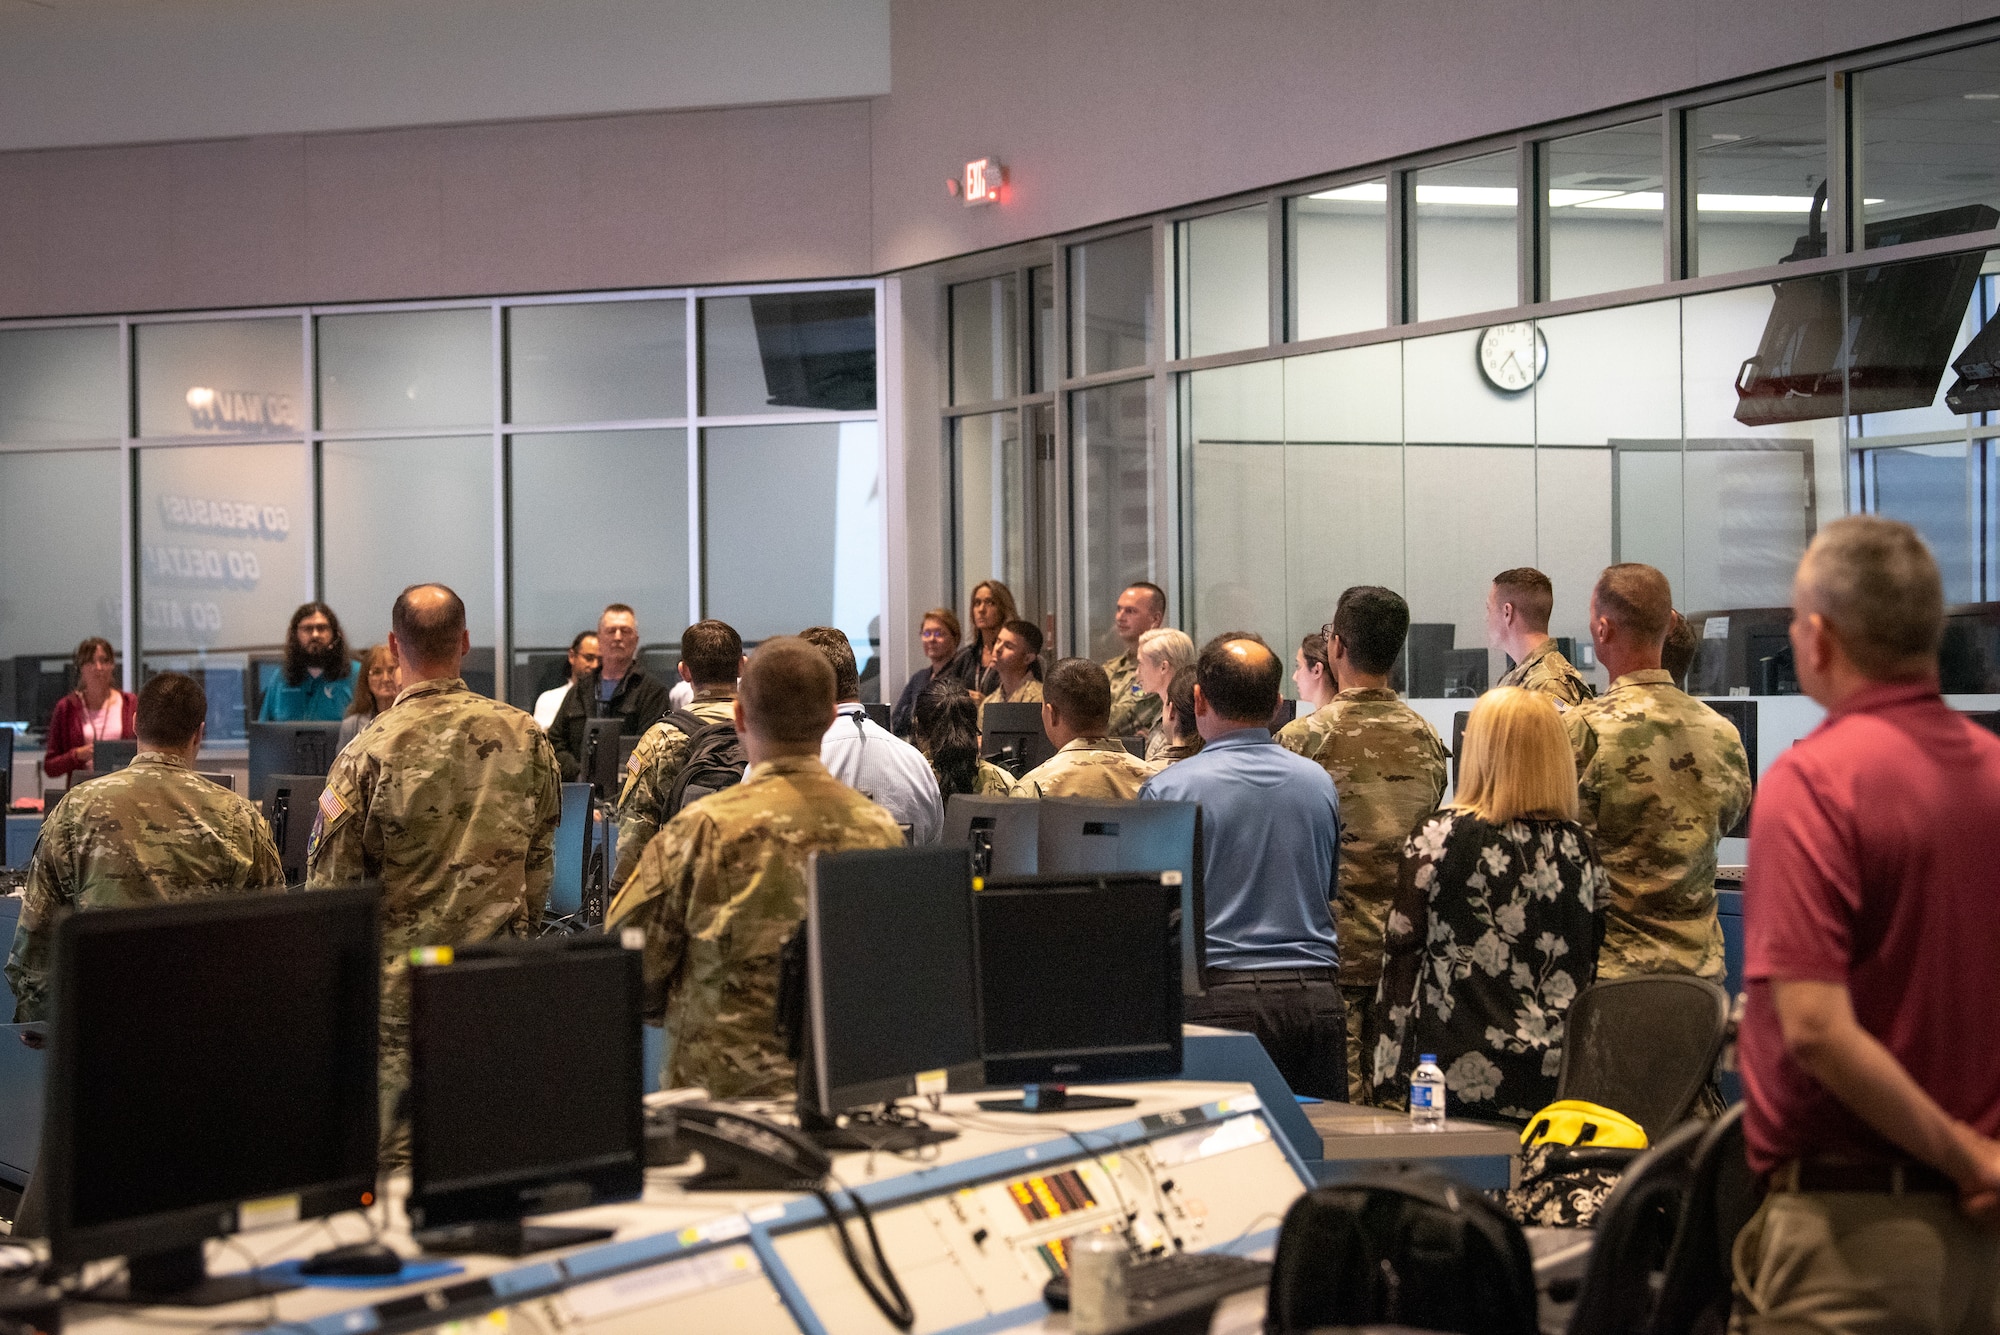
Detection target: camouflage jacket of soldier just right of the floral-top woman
<box><xmin>1564</xmin><ymin>668</ymin><xmax>1750</xmax><ymax>977</ymax></box>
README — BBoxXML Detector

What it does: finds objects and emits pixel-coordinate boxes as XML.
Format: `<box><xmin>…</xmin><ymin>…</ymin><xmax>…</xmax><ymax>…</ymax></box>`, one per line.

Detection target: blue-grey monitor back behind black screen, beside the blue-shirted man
<box><xmin>1036</xmin><ymin>797</ymin><xmax>1208</xmax><ymax>997</ymax></box>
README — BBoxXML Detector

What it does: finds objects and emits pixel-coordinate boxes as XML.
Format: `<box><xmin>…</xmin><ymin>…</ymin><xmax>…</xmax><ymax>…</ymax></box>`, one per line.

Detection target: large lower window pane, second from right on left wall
<box><xmin>508</xmin><ymin>430</ymin><xmax>692</xmax><ymax>683</ymax></box>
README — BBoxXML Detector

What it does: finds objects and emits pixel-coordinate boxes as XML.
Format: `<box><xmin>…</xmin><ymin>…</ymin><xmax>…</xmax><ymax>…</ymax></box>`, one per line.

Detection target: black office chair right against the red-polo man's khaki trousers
<box><xmin>1650</xmin><ymin>1103</ymin><xmax>1758</xmax><ymax>1335</ymax></box>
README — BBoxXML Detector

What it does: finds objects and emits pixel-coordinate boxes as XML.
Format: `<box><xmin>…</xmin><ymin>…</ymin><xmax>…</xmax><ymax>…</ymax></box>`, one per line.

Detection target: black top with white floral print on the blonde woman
<box><xmin>1372</xmin><ymin>809</ymin><xmax>1606</xmax><ymax>1123</ymax></box>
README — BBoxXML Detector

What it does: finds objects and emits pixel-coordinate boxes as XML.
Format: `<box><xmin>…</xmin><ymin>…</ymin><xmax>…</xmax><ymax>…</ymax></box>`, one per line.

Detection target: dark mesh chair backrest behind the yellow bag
<box><xmin>1556</xmin><ymin>973</ymin><xmax>1730</xmax><ymax>1145</ymax></box>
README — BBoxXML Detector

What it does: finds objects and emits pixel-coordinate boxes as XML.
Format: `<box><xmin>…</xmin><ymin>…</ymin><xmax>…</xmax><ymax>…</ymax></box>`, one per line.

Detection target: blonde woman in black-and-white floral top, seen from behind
<box><xmin>1372</xmin><ymin>687</ymin><xmax>1608</xmax><ymax>1123</ymax></box>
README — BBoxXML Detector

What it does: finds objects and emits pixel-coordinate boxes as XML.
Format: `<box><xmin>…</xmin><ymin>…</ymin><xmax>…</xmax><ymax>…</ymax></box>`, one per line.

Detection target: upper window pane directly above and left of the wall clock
<box><xmin>1414</xmin><ymin>148</ymin><xmax>1520</xmax><ymax>320</ymax></box>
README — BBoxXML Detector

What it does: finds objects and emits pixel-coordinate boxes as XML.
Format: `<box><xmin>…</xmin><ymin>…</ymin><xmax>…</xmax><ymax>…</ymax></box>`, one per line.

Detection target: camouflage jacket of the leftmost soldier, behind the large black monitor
<box><xmin>6</xmin><ymin>751</ymin><xmax>284</xmax><ymax>1023</ymax></box>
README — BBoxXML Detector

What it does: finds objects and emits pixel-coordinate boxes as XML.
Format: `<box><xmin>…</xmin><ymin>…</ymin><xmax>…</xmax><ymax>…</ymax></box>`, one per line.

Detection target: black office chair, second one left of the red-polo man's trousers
<box><xmin>1568</xmin><ymin>1121</ymin><xmax>1708</xmax><ymax>1335</ymax></box>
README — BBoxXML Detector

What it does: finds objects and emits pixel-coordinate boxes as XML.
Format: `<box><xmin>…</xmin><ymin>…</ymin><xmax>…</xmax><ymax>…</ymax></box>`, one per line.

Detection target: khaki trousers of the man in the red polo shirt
<box><xmin>1730</xmin><ymin>1191</ymin><xmax>2000</xmax><ymax>1335</ymax></box>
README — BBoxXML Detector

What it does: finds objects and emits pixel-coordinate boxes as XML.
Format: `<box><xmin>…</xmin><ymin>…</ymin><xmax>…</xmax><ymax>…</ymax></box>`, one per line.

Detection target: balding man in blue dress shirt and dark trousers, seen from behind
<box><xmin>1140</xmin><ymin>632</ymin><xmax>1348</xmax><ymax>1101</ymax></box>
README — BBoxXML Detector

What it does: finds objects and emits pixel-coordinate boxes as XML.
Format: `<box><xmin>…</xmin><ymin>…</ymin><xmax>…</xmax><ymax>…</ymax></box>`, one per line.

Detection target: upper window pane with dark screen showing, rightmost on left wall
<box><xmin>702</xmin><ymin>288</ymin><xmax>876</xmax><ymax>418</ymax></box>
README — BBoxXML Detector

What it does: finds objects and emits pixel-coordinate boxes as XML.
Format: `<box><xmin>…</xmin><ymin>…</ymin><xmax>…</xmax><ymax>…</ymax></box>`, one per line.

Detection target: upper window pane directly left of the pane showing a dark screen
<box><xmin>506</xmin><ymin>302</ymin><xmax>688</xmax><ymax>425</ymax></box>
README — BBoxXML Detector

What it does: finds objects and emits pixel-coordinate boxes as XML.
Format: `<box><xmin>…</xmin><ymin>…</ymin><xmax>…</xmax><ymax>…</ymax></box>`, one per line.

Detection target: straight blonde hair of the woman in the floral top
<box><xmin>1452</xmin><ymin>685</ymin><xmax>1576</xmax><ymax>825</ymax></box>
